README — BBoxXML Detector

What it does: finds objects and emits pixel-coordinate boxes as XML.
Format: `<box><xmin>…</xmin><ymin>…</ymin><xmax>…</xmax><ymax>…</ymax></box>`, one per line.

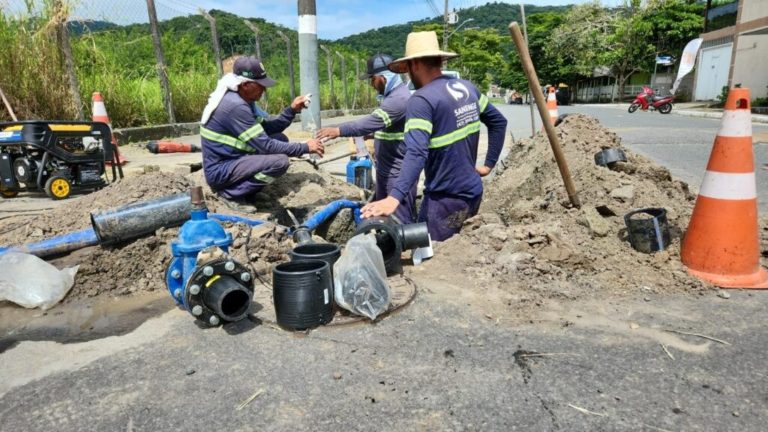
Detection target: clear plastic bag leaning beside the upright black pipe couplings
<box><xmin>333</xmin><ymin>234</ymin><xmax>392</xmax><ymax>320</ymax></box>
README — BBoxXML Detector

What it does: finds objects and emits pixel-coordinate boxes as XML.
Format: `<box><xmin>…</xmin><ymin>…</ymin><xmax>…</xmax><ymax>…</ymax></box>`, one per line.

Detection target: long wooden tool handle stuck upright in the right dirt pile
<box><xmin>509</xmin><ymin>22</ymin><xmax>581</xmax><ymax>208</ymax></box>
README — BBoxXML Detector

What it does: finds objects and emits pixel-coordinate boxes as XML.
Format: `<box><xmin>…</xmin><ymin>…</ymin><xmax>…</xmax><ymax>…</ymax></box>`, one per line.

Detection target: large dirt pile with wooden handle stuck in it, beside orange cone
<box><xmin>424</xmin><ymin>115</ymin><xmax>710</xmax><ymax>314</ymax></box>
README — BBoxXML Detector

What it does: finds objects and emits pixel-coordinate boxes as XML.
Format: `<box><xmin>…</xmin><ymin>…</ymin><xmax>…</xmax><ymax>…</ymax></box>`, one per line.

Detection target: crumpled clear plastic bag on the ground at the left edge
<box><xmin>0</xmin><ymin>252</ymin><xmax>80</xmax><ymax>310</ymax></box>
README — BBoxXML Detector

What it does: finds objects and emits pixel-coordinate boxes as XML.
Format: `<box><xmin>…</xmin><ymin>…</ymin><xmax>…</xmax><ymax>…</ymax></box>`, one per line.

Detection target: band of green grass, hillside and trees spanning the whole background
<box><xmin>0</xmin><ymin>0</ymin><xmax>704</xmax><ymax>127</ymax></box>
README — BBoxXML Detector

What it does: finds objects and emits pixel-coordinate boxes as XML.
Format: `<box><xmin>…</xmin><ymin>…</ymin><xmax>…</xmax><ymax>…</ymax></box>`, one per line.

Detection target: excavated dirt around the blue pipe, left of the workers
<box><xmin>0</xmin><ymin>162</ymin><xmax>361</xmax><ymax>302</ymax></box>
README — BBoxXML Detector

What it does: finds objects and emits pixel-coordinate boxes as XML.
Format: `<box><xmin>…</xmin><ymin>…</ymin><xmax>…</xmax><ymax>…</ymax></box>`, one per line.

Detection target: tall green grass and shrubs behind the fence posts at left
<box><xmin>0</xmin><ymin>5</ymin><xmax>375</xmax><ymax>127</ymax></box>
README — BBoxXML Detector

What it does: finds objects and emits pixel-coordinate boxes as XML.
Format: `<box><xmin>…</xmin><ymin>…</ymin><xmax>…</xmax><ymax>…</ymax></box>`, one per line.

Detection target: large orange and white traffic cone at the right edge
<box><xmin>680</xmin><ymin>88</ymin><xmax>768</xmax><ymax>289</ymax></box>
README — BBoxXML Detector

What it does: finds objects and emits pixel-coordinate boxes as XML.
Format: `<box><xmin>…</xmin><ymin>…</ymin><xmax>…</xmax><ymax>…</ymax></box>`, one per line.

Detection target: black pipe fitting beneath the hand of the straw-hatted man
<box><xmin>355</xmin><ymin>217</ymin><xmax>430</xmax><ymax>276</ymax></box>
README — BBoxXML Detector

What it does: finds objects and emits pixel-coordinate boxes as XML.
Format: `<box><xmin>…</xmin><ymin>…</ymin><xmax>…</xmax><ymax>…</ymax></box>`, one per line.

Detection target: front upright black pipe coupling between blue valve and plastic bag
<box><xmin>272</xmin><ymin>260</ymin><xmax>333</xmax><ymax>330</ymax></box>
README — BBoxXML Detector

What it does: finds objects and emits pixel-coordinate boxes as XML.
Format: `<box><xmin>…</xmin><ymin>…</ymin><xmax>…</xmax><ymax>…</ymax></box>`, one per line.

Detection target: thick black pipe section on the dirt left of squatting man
<box><xmin>91</xmin><ymin>194</ymin><xmax>192</xmax><ymax>245</ymax></box>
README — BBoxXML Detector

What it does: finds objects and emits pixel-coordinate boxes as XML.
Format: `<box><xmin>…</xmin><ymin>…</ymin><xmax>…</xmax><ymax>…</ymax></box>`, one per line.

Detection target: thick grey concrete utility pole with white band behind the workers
<box><xmin>298</xmin><ymin>0</ymin><xmax>320</xmax><ymax>130</ymax></box>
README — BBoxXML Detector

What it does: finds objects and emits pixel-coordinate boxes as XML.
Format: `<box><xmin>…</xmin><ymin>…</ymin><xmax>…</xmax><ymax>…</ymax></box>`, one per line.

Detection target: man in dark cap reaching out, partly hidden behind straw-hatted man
<box><xmin>317</xmin><ymin>53</ymin><xmax>416</xmax><ymax>223</ymax></box>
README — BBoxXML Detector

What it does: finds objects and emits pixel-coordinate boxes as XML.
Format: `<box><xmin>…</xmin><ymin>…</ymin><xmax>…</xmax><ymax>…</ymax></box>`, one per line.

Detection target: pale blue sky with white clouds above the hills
<box><xmin>0</xmin><ymin>0</ymin><xmax>623</xmax><ymax>40</ymax></box>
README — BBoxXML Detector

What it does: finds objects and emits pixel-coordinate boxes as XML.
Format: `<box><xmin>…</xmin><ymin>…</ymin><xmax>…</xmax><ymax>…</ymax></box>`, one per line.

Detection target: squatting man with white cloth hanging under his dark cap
<box><xmin>200</xmin><ymin>57</ymin><xmax>324</xmax><ymax>204</ymax></box>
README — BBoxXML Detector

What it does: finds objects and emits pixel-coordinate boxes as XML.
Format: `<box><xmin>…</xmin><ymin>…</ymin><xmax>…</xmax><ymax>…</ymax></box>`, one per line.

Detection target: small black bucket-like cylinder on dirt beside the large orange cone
<box><xmin>624</xmin><ymin>208</ymin><xmax>669</xmax><ymax>253</ymax></box>
